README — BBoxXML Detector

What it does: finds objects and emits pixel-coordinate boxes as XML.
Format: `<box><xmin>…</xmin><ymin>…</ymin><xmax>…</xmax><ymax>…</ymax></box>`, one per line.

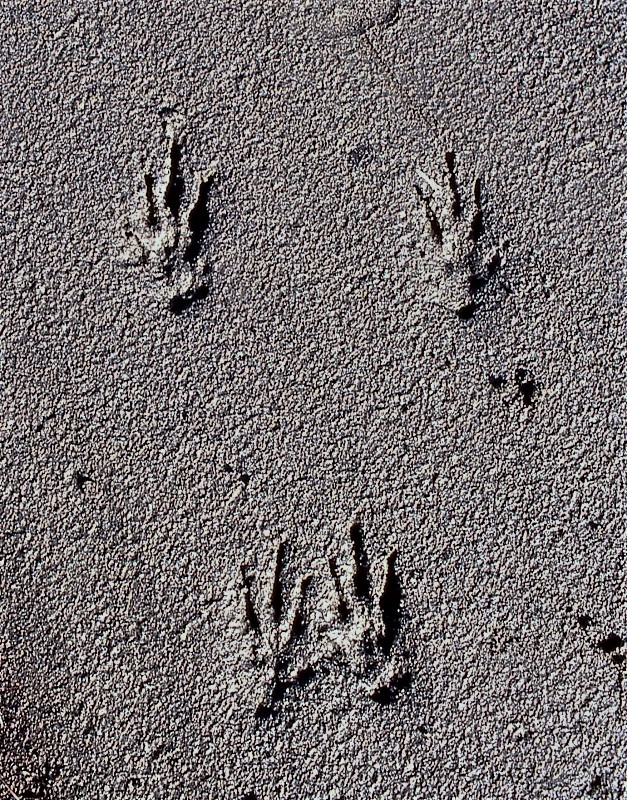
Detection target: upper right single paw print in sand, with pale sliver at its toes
<box><xmin>416</xmin><ymin>151</ymin><xmax>507</xmax><ymax>321</ymax></box>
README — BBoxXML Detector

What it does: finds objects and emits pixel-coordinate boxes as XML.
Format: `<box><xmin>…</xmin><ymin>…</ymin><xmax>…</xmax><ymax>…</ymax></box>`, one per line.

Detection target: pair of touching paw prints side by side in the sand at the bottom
<box><xmin>242</xmin><ymin>522</ymin><xmax>411</xmax><ymax>719</ymax></box>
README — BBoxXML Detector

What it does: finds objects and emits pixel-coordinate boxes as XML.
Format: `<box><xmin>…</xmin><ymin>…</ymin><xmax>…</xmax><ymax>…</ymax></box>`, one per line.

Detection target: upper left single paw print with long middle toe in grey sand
<box><xmin>126</xmin><ymin>118</ymin><xmax>216</xmax><ymax>315</ymax></box>
